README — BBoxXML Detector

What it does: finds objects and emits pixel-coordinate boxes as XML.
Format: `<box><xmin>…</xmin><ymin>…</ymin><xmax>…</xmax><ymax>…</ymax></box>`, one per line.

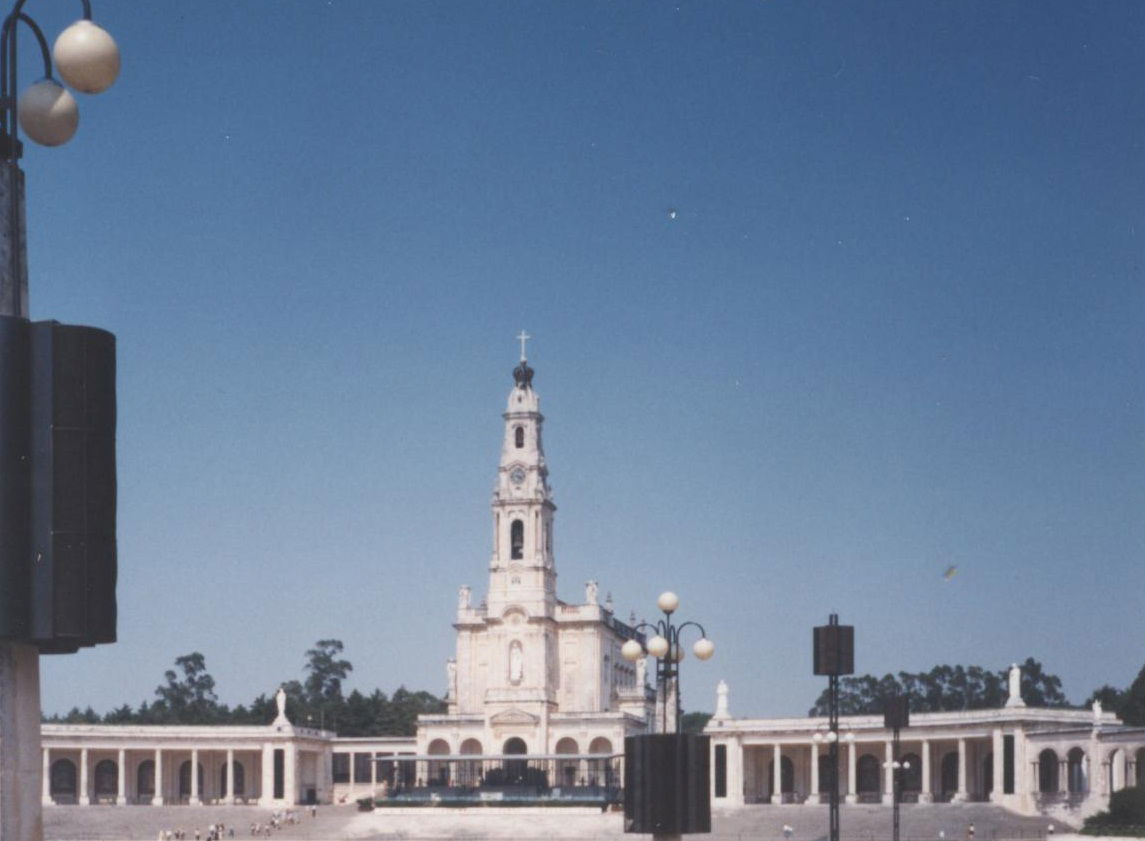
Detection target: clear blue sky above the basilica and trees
<box><xmin>22</xmin><ymin>0</ymin><xmax>1145</xmax><ymax>715</ymax></box>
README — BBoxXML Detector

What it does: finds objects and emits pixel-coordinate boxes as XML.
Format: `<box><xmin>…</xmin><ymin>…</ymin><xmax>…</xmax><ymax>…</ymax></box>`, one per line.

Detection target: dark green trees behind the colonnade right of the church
<box><xmin>807</xmin><ymin>657</ymin><xmax>1145</xmax><ymax>725</ymax></box>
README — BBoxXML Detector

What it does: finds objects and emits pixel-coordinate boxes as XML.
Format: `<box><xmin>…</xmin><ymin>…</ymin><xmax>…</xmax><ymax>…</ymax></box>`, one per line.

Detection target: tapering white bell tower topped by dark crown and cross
<box><xmin>489</xmin><ymin>331</ymin><xmax>556</xmax><ymax>616</ymax></box>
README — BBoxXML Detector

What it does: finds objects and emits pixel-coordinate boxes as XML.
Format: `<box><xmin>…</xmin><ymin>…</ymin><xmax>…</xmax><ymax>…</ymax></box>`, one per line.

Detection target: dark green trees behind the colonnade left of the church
<box><xmin>45</xmin><ymin>639</ymin><xmax>445</xmax><ymax>736</ymax></box>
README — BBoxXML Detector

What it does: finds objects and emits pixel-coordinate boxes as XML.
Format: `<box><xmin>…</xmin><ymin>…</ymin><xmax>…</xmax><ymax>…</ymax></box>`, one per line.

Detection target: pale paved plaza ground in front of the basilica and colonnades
<box><xmin>44</xmin><ymin>803</ymin><xmax>1062</xmax><ymax>841</ymax></box>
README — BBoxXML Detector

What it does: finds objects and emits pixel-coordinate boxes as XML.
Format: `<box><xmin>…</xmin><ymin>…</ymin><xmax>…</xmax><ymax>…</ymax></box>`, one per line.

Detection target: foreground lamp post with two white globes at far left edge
<box><xmin>0</xmin><ymin>0</ymin><xmax>123</xmax><ymax>841</ymax></box>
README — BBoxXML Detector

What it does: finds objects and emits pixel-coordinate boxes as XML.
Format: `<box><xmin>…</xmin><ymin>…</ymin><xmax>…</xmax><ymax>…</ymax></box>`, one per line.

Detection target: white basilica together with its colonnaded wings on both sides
<box><xmin>42</xmin><ymin>346</ymin><xmax>1145</xmax><ymax>820</ymax></box>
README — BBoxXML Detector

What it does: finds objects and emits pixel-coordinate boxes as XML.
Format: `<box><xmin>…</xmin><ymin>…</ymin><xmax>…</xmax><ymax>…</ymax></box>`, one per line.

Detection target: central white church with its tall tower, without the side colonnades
<box><xmin>418</xmin><ymin>353</ymin><xmax>653</xmax><ymax>755</ymax></box>
